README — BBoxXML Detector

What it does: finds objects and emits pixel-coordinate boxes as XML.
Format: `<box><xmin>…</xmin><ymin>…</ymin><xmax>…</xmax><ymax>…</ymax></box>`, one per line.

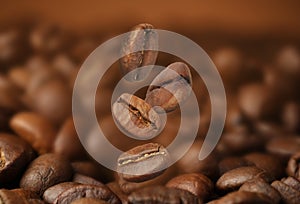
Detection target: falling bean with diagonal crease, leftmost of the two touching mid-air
<box><xmin>112</xmin><ymin>93</ymin><xmax>162</xmax><ymax>139</ymax></box>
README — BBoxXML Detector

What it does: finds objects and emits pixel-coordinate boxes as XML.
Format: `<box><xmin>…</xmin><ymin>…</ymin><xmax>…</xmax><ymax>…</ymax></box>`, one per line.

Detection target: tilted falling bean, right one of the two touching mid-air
<box><xmin>145</xmin><ymin>62</ymin><xmax>192</xmax><ymax>112</ymax></box>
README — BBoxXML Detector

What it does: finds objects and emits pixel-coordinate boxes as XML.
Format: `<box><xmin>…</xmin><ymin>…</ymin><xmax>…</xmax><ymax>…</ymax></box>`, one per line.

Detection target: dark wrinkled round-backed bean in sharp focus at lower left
<box><xmin>20</xmin><ymin>154</ymin><xmax>73</xmax><ymax>195</ymax></box>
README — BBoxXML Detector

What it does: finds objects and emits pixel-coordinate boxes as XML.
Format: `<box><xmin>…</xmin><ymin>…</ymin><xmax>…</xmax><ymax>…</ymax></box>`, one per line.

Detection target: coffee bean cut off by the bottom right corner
<box><xmin>271</xmin><ymin>181</ymin><xmax>300</xmax><ymax>204</ymax></box>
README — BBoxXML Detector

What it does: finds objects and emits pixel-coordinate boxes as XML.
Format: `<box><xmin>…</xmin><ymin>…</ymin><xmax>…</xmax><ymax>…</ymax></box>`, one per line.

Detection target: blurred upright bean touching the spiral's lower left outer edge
<box><xmin>53</xmin><ymin>117</ymin><xmax>86</xmax><ymax>161</ymax></box>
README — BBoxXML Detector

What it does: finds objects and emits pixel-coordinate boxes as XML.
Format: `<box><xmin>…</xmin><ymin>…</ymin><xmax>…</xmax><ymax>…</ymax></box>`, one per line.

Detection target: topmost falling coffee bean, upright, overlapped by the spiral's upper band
<box><xmin>120</xmin><ymin>23</ymin><xmax>158</xmax><ymax>81</ymax></box>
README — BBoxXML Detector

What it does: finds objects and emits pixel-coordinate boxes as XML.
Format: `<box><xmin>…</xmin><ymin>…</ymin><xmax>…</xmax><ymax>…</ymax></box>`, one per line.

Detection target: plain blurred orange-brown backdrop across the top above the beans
<box><xmin>0</xmin><ymin>0</ymin><xmax>300</xmax><ymax>38</ymax></box>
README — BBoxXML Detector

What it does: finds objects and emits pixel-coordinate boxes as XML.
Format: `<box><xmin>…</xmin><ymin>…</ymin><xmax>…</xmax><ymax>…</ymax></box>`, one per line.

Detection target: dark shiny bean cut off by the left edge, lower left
<box><xmin>0</xmin><ymin>133</ymin><xmax>35</xmax><ymax>186</ymax></box>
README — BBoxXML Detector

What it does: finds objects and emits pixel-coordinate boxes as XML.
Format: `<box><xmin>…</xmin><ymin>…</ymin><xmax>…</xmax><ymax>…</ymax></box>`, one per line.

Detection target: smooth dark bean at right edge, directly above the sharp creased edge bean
<box><xmin>266</xmin><ymin>136</ymin><xmax>300</xmax><ymax>161</ymax></box>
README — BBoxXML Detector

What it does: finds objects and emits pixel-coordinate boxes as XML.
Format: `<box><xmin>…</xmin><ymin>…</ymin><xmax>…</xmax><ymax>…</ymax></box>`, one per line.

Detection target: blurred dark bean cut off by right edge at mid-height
<box><xmin>281</xmin><ymin>102</ymin><xmax>300</xmax><ymax>132</ymax></box>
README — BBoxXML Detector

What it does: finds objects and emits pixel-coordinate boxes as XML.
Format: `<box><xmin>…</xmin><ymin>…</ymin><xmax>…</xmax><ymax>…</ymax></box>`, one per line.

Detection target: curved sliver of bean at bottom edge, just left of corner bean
<box><xmin>239</xmin><ymin>178</ymin><xmax>281</xmax><ymax>203</ymax></box>
